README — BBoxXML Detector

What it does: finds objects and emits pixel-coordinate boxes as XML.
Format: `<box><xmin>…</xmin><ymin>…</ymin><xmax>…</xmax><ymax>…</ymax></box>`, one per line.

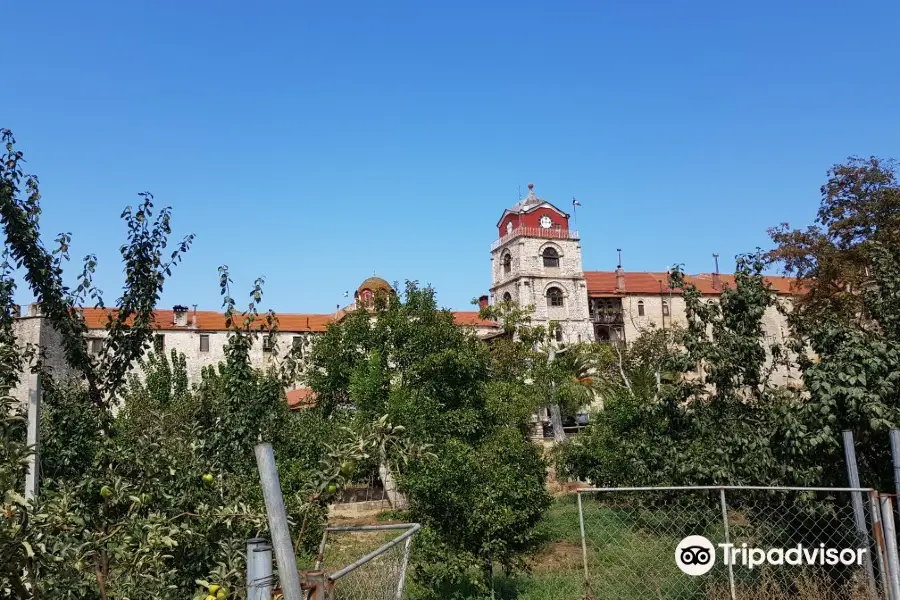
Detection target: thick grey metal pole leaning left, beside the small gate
<box><xmin>255</xmin><ymin>444</ymin><xmax>303</xmax><ymax>600</ymax></box>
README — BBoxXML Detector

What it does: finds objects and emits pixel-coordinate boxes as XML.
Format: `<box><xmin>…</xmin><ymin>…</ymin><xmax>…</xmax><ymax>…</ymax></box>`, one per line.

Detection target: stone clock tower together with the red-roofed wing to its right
<box><xmin>490</xmin><ymin>185</ymin><xmax>793</xmax><ymax>350</ymax></box>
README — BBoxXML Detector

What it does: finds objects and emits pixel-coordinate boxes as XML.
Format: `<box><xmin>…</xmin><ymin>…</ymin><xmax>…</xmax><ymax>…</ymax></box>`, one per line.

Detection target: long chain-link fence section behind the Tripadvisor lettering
<box><xmin>578</xmin><ymin>488</ymin><xmax>885</xmax><ymax>600</ymax></box>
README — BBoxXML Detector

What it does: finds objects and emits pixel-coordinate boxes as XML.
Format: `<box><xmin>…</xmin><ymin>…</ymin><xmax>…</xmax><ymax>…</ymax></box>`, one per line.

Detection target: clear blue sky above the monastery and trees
<box><xmin>0</xmin><ymin>0</ymin><xmax>900</xmax><ymax>312</ymax></box>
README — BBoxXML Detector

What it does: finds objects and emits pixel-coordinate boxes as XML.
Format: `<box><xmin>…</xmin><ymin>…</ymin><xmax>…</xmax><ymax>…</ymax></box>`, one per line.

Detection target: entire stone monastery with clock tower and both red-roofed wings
<box><xmin>15</xmin><ymin>185</ymin><xmax>795</xmax><ymax>404</ymax></box>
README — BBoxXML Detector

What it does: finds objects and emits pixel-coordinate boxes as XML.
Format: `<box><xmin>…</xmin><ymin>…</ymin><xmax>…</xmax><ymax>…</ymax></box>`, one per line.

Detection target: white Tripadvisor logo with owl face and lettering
<box><xmin>675</xmin><ymin>535</ymin><xmax>868</xmax><ymax>577</ymax></box>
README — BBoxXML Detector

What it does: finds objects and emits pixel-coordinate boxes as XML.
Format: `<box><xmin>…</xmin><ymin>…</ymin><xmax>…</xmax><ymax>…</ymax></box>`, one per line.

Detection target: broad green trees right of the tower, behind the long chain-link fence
<box><xmin>560</xmin><ymin>254</ymin><xmax>818</xmax><ymax>485</ymax></box>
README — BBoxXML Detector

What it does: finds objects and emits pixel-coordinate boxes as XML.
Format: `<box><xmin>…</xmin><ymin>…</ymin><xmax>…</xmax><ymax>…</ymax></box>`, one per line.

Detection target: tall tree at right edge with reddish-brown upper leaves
<box><xmin>768</xmin><ymin>158</ymin><xmax>900</xmax><ymax>489</ymax></box>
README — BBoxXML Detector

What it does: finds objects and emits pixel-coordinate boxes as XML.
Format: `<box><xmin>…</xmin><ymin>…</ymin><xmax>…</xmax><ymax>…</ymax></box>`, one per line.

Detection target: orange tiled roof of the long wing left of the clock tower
<box><xmin>77</xmin><ymin>308</ymin><xmax>499</xmax><ymax>333</ymax></box>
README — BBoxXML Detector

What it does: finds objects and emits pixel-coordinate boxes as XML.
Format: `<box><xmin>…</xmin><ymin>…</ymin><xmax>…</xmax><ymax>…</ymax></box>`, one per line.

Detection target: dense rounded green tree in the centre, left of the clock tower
<box><xmin>308</xmin><ymin>282</ymin><xmax>549</xmax><ymax>595</ymax></box>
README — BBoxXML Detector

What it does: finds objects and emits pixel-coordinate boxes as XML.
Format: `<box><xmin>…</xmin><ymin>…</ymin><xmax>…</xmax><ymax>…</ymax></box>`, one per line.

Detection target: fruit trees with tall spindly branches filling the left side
<box><xmin>0</xmin><ymin>131</ymin><xmax>364</xmax><ymax>600</ymax></box>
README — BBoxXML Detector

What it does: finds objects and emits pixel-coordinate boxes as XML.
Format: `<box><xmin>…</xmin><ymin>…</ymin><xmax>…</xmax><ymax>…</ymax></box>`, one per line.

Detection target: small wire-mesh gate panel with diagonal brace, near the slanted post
<box><xmin>316</xmin><ymin>524</ymin><xmax>419</xmax><ymax>600</ymax></box>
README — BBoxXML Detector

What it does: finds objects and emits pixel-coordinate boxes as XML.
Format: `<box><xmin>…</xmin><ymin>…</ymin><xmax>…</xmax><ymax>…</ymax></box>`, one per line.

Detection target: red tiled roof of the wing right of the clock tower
<box><xmin>584</xmin><ymin>271</ymin><xmax>799</xmax><ymax>296</ymax></box>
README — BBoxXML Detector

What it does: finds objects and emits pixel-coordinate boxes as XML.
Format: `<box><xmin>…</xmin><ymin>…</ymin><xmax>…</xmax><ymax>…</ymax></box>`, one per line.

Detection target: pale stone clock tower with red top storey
<box><xmin>491</xmin><ymin>183</ymin><xmax>594</xmax><ymax>343</ymax></box>
